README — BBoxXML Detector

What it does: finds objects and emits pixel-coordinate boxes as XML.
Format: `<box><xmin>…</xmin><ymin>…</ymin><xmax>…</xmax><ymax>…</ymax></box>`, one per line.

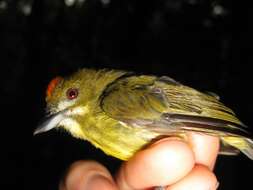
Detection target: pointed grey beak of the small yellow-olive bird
<box><xmin>33</xmin><ymin>111</ymin><xmax>65</xmax><ymax>135</ymax></box>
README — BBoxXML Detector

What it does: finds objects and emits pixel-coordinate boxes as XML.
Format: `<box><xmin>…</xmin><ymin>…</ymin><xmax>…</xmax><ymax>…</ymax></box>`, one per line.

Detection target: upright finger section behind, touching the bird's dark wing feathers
<box><xmin>188</xmin><ymin>132</ymin><xmax>220</xmax><ymax>170</ymax></box>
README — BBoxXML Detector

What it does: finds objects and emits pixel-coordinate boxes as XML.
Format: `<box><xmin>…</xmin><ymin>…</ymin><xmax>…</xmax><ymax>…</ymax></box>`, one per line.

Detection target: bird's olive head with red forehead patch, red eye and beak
<box><xmin>34</xmin><ymin>69</ymin><xmax>106</xmax><ymax>137</ymax></box>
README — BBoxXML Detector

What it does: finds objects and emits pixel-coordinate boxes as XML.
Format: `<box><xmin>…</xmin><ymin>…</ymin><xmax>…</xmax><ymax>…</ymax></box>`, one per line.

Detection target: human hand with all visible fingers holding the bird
<box><xmin>60</xmin><ymin>133</ymin><xmax>219</xmax><ymax>190</ymax></box>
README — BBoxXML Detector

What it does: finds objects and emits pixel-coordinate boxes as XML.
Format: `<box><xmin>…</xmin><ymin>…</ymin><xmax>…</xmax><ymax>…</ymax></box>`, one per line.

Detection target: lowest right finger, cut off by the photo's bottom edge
<box><xmin>167</xmin><ymin>165</ymin><xmax>219</xmax><ymax>190</ymax></box>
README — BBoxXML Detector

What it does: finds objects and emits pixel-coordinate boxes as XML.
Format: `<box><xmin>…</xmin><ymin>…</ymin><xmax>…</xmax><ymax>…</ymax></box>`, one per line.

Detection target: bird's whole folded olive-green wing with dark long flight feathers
<box><xmin>101</xmin><ymin>75</ymin><xmax>245</xmax><ymax>135</ymax></box>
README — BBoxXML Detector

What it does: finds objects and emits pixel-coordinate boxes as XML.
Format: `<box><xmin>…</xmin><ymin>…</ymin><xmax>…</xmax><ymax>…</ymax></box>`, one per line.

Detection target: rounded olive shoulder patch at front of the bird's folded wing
<box><xmin>101</xmin><ymin>76</ymin><xmax>168</xmax><ymax>121</ymax></box>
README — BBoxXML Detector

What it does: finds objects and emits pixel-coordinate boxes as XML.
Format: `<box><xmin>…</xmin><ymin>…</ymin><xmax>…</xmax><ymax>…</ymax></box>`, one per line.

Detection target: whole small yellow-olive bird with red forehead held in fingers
<box><xmin>34</xmin><ymin>69</ymin><xmax>253</xmax><ymax>160</ymax></box>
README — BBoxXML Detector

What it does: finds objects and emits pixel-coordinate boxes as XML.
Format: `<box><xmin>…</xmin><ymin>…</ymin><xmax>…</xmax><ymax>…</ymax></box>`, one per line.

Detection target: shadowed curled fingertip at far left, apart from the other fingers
<box><xmin>60</xmin><ymin>161</ymin><xmax>117</xmax><ymax>190</ymax></box>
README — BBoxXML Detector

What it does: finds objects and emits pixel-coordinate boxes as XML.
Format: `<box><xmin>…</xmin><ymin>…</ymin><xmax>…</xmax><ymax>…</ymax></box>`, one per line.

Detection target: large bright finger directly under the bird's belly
<box><xmin>116</xmin><ymin>138</ymin><xmax>195</xmax><ymax>190</ymax></box>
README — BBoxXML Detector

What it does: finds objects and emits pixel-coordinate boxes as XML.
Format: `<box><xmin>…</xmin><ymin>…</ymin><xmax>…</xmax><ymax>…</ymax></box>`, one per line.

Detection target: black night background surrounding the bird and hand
<box><xmin>0</xmin><ymin>0</ymin><xmax>253</xmax><ymax>190</ymax></box>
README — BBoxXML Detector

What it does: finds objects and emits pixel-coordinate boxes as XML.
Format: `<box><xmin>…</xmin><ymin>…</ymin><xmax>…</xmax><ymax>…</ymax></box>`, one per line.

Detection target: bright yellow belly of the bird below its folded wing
<box><xmin>88</xmin><ymin>123</ymin><xmax>159</xmax><ymax>160</ymax></box>
